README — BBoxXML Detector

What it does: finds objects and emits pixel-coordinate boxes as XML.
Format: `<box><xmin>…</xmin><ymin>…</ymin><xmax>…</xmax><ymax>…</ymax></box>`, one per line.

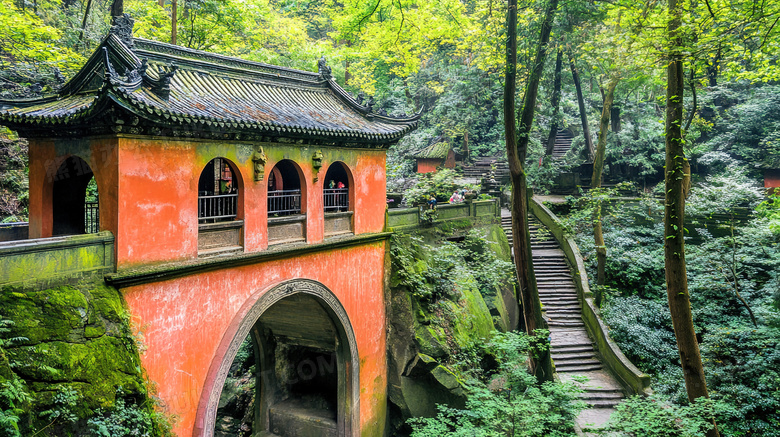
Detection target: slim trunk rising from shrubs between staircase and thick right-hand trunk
<box><xmin>590</xmin><ymin>76</ymin><xmax>620</xmax><ymax>306</ymax></box>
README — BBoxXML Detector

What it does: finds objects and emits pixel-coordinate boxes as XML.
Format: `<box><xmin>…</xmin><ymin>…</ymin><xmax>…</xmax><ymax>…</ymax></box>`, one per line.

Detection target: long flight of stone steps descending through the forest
<box><xmin>501</xmin><ymin>211</ymin><xmax>624</xmax><ymax>422</ymax></box>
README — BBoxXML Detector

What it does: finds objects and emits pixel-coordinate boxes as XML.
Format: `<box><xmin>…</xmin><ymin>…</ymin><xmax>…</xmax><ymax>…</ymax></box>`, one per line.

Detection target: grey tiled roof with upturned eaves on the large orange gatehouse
<box><xmin>0</xmin><ymin>19</ymin><xmax>420</xmax><ymax>147</ymax></box>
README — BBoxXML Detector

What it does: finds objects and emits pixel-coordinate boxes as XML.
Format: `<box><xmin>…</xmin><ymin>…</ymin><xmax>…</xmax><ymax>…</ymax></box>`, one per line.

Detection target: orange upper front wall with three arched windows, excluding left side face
<box><xmin>111</xmin><ymin>138</ymin><xmax>385</xmax><ymax>269</ymax></box>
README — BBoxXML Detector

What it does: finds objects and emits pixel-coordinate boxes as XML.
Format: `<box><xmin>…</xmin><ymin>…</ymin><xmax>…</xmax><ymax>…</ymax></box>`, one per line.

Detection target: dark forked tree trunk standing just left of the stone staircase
<box><xmin>504</xmin><ymin>0</ymin><xmax>558</xmax><ymax>380</ymax></box>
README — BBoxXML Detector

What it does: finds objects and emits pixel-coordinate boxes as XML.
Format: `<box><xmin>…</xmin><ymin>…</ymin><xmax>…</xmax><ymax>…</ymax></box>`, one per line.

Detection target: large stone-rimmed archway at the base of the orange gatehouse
<box><xmin>204</xmin><ymin>280</ymin><xmax>359</xmax><ymax>437</ymax></box>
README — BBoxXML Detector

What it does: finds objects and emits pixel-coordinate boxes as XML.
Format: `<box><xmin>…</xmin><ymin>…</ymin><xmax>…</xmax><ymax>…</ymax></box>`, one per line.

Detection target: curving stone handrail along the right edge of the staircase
<box><xmin>528</xmin><ymin>198</ymin><xmax>652</xmax><ymax>395</ymax></box>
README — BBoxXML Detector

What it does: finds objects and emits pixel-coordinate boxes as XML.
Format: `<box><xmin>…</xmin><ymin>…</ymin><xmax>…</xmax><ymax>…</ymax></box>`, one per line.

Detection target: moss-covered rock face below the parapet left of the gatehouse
<box><xmin>0</xmin><ymin>278</ymin><xmax>166</xmax><ymax>436</ymax></box>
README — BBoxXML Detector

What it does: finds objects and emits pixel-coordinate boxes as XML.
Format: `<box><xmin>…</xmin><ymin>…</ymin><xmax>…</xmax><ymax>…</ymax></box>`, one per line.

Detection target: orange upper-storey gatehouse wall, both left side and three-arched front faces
<box><xmin>30</xmin><ymin>138</ymin><xmax>386</xmax><ymax>270</ymax></box>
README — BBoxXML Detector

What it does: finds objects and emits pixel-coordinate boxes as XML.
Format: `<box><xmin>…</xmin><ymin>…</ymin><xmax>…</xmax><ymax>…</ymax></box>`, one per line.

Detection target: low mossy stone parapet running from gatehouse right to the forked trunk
<box><xmin>385</xmin><ymin>199</ymin><xmax>501</xmax><ymax>230</ymax></box>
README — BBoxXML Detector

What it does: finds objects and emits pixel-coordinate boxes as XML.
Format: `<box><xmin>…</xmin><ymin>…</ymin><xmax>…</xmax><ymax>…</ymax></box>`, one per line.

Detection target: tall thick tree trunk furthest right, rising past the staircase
<box><xmin>664</xmin><ymin>0</ymin><xmax>719</xmax><ymax>437</ymax></box>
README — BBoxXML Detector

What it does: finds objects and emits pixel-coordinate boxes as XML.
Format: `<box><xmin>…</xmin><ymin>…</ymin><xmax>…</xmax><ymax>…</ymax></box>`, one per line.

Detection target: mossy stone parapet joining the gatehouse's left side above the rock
<box><xmin>0</xmin><ymin>231</ymin><xmax>115</xmax><ymax>284</ymax></box>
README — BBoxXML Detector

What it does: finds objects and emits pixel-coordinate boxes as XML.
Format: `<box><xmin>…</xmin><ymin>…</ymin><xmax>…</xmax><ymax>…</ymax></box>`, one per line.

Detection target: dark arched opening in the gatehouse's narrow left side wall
<box><xmin>52</xmin><ymin>156</ymin><xmax>100</xmax><ymax>235</ymax></box>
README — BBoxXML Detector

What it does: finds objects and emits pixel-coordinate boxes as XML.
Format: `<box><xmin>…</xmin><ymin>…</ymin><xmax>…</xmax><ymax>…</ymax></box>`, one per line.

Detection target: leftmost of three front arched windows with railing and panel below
<box><xmin>198</xmin><ymin>158</ymin><xmax>244</xmax><ymax>256</ymax></box>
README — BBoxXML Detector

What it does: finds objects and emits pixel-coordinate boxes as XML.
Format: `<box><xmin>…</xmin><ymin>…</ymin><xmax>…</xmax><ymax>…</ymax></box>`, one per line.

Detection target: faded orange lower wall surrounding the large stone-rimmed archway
<box><xmin>122</xmin><ymin>242</ymin><xmax>387</xmax><ymax>436</ymax></box>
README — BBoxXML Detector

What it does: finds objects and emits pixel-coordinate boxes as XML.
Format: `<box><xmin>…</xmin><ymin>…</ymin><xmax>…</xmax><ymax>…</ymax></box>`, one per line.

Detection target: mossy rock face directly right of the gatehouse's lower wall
<box><xmin>386</xmin><ymin>221</ymin><xmax>519</xmax><ymax>433</ymax></box>
